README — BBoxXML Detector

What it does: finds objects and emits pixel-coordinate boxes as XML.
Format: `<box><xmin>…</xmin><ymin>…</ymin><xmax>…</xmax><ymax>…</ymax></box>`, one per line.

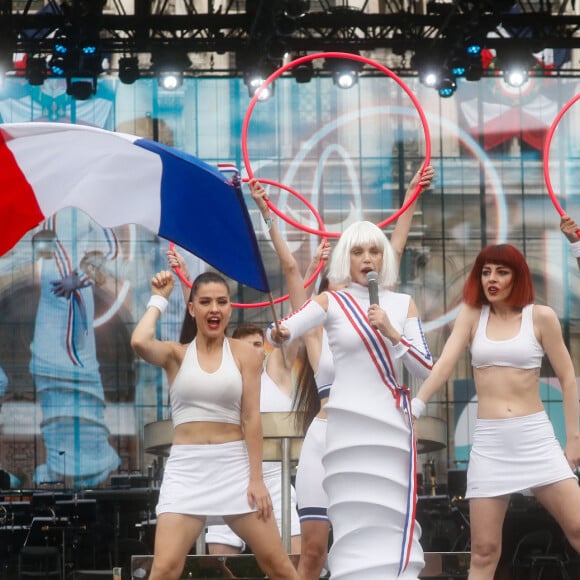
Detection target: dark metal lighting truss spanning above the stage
<box><xmin>0</xmin><ymin>0</ymin><xmax>580</xmax><ymax>72</ymax></box>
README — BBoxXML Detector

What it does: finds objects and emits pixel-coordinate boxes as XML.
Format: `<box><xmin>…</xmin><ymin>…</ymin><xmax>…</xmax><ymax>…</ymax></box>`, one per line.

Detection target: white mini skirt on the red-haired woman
<box><xmin>465</xmin><ymin>411</ymin><xmax>576</xmax><ymax>498</ymax></box>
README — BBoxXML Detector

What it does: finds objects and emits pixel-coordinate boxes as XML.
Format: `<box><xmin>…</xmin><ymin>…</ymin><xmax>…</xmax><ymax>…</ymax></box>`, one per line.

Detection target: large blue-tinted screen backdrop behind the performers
<box><xmin>0</xmin><ymin>71</ymin><xmax>580</xmax><ymax>487</ymax></box>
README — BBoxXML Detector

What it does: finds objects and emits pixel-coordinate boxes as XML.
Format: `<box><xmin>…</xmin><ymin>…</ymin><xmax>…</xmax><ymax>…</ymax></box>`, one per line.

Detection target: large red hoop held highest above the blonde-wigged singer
<box><xmin>242</xmin><ymin>52</ymin><xmax>431</xmax><ymax>238</ymax></box>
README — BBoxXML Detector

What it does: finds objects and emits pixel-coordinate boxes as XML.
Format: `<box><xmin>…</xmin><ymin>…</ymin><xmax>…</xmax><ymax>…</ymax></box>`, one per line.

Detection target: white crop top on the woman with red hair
<box><xmin>471</xmin><ymin>304</ymin><xmax>544</xmax><ymax>369</ymax></box>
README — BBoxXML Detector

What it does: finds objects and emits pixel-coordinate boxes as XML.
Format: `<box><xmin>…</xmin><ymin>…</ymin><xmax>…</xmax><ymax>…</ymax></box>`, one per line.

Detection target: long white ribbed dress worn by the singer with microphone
<box><xmin>270</xmin><ymin>284</ymin><xmax>431</xmax><ymax>580</ymax></box>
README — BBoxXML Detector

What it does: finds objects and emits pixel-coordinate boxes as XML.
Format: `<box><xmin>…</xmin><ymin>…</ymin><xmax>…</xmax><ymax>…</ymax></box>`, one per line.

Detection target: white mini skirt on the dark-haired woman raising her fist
<box><xmin>156</xmin><ymin>440</ymin><xmax>256</xmax><ymax>525</ymax></box>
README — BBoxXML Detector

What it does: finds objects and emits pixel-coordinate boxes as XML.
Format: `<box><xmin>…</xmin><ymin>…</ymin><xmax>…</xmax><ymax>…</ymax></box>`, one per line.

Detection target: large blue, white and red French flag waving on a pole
<box><xmin>0</xmin><ymin>122</ymin><xmax>269</xmax><ymax>292</ymax></box>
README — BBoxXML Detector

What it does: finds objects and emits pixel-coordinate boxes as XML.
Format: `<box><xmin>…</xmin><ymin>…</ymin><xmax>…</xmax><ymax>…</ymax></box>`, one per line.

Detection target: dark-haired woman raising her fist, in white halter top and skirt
<box><xmin>131</xmin><ymin>271</ymin><xmax>298</xmax><ymax>580</ymax></box>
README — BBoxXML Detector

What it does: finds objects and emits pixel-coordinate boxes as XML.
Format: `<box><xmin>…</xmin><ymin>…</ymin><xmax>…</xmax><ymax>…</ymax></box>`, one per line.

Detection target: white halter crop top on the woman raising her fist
<box><xmin>170</xmin><ymin>339</ymin><xmax>242</xmax><ymax>427</ymax></box>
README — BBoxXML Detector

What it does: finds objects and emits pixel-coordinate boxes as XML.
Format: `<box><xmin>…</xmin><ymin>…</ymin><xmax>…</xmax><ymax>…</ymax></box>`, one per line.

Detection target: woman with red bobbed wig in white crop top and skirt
<box><xmin>412</xmin><ymin>244</ymin><xmax>580</xmax><ymax>580</ymax></box>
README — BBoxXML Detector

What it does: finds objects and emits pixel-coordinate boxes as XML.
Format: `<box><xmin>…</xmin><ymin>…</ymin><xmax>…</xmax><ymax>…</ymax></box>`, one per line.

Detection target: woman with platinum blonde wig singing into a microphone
<box><xmin>268</xmin><ymin>222</ymin><xmax>432</xmax><ymax>580</ymax></box>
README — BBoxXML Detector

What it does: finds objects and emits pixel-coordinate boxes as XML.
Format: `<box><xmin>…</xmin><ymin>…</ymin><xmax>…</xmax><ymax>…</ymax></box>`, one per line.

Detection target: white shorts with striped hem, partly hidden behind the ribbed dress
<box><xmin>296</xmin><ymin>417</ymin><xmax>328</xmax><ymax>522</ymax></box>
